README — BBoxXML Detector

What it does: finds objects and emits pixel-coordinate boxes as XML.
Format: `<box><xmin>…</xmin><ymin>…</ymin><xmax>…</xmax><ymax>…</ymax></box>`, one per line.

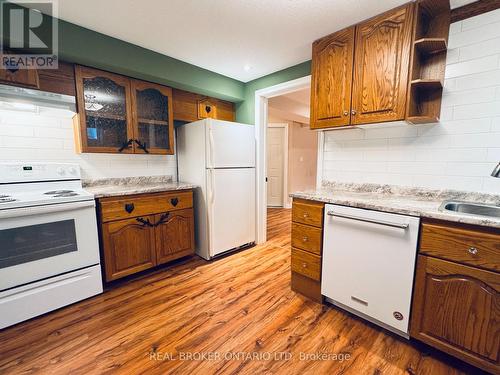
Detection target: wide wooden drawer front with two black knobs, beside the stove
<box><xmin>99</xmin><ymin>191</ymin><xmax>193</xmax><ymax>222</ymax></box>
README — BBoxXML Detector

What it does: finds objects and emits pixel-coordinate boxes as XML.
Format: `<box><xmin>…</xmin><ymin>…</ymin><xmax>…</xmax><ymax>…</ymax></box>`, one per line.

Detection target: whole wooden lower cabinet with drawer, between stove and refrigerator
<box><xmin>98</xmin><ymin>191</ymin><xmax>195</xmax><ymax>282</ymax></box>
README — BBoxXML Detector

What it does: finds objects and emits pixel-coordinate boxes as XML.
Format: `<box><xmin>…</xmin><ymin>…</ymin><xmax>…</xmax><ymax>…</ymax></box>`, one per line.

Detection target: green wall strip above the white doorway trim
<box><xmin>236</xmin><ymin>61</ymin><xmax>311</xmax><ymax>124</ymax></box>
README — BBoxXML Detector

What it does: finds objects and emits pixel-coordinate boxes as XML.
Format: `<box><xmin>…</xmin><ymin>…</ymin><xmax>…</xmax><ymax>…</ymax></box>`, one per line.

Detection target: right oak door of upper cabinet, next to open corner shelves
<box><xmin>351</xmin><ymin>3</ymin><xmax>413</xmax><ymax>124</ymax></box>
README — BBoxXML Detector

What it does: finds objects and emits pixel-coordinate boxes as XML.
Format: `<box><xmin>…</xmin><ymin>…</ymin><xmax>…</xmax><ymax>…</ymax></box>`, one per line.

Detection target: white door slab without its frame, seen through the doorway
<box><xmin>267</xmin><ymin>127</ymin><xmax>285</xmax><ymax>207</ymax></box>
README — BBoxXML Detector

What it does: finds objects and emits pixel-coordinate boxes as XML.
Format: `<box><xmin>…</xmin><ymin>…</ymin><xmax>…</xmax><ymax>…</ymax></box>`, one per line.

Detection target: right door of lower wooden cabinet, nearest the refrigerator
<box><xmin>155</xmin><ymin>209</ymin><xmax>194</xmax><ymax>264</ymax></box>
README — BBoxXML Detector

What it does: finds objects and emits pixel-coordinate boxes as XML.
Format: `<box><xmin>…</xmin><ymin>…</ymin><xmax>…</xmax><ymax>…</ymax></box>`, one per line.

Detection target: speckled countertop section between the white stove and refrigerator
<box><xmin>83</xmin><ymin>176</ymin><xmax>196</xmax><ymax>198</ymax></box>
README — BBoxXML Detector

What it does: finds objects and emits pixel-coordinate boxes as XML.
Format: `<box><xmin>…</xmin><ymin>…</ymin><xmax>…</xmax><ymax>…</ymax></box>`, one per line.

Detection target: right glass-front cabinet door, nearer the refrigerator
<box><xmin>131</xmin><ymin>80</ymin><xmax>174</xmax><ymax>154</ymax></box>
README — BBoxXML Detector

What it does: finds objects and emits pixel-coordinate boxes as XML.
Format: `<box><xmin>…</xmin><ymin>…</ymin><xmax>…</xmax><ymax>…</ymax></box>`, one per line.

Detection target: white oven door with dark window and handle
<box><xmin>0</xmin><ymin>200</ymin><xmax>99</xmax><ymax>291</ymax></box>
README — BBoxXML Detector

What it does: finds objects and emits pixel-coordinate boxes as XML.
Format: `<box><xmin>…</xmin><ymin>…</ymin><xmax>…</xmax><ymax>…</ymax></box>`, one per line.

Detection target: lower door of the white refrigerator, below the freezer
<box><xmin>207</xmin><ymin>168</ymin><xmax>255</xmax><ymax>257</ymax></box>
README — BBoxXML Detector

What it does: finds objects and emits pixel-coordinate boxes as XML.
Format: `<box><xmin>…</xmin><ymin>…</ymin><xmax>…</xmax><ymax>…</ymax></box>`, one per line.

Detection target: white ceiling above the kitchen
<box><xmin>51</xmin><ymin>0</ymin><xmax>473</xmax><ymax>82</ymax></box>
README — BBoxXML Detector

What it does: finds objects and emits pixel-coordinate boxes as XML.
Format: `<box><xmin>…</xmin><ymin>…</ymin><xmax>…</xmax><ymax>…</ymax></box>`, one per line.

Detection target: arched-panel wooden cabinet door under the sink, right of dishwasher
<box><xmin>410</xmin><ymin>222</ymin><xmax>500</xmax><ymax>374</ymax></box>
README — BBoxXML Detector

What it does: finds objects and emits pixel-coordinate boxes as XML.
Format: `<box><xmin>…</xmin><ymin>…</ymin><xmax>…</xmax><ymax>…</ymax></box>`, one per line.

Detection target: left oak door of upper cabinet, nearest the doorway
<box><xmin>311</xmin><ymin>26</ymin><xmax>355</xmax><ymax>129</ymax></box>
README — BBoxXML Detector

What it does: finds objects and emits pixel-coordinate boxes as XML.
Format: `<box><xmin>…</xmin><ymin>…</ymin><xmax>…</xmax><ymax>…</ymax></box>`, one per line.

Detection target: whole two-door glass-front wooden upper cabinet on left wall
<box><xmin>74</xmin><ymin>65</ymin><xmax>174</xmax><ymax>154</ymax></box>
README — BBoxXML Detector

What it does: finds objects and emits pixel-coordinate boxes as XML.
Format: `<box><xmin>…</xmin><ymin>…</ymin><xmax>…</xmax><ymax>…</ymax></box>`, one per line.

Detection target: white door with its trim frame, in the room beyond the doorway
<box><xmin>266</xmin><ymin>123</ymin><xmax>288</xmax><ymax>207</ymax></box>
